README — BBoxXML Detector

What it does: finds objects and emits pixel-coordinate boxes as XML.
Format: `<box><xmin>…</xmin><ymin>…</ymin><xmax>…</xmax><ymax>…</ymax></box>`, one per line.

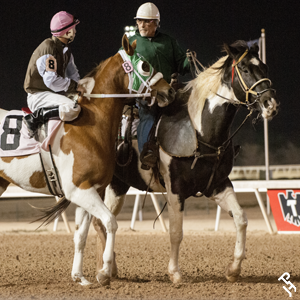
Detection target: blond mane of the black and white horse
<box><xmin>182</xmin><ymin>55</ymin><xmax>228</xmax><ymax>128</ymax></box>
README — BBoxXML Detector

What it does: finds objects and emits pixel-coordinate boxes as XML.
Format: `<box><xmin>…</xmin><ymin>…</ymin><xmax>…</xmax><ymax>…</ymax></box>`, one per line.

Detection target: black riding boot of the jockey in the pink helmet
<box><xmin>23</xmin><ymin>106</ymin><xmax>59</xmax><ymax>138</ymax></box>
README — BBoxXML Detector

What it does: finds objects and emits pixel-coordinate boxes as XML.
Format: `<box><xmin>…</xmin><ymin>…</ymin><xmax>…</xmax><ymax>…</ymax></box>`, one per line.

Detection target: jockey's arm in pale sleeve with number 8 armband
<box><xmin>36</xmin><ymin>54</ymin><xmax>79</xmax><ymax>92</ymax></box>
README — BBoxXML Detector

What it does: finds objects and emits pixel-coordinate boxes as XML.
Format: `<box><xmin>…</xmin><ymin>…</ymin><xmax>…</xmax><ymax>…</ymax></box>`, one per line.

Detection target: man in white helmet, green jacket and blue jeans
<box><xmin>129</xmin><ymin>2</ymin><xmax>190</xmax><ymax>170</ymax></box>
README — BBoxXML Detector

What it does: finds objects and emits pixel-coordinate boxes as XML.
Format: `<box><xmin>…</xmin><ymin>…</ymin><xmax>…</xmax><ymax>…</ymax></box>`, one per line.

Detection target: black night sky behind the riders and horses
<box><xmin>0</xmin><ymin>0</ymin><xmax>300</xmax><ymax>165</ymax></box>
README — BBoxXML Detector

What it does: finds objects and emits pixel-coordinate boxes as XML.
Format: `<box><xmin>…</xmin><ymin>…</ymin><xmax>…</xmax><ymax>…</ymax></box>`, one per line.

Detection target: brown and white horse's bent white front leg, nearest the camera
<box><xmin>66</xmin><ymin>187</ymin><xmax>118</xmax><ymax>285</ymax></box>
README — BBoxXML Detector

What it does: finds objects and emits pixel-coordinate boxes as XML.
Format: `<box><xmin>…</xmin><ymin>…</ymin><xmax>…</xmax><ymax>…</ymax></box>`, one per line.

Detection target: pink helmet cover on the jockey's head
<box><xmin>50</xmin><ymin>11</ymin><xmax>79</xmax><ymax>36</ymax></box>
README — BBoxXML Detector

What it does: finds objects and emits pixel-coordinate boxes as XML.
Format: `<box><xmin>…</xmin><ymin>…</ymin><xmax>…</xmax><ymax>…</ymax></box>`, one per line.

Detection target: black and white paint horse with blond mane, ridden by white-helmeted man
<box><xmin>82</xmin><ymin>41</ymin><xmax>278</xmax><ymax>283</ymax></box>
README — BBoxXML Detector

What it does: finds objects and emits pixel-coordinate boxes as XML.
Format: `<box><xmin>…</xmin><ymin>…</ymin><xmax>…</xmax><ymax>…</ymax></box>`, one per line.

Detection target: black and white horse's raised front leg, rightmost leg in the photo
<box><xmin>212</xmin><ymin>187</ymin><xmax>248</xmax><ymax>282</ymax></box>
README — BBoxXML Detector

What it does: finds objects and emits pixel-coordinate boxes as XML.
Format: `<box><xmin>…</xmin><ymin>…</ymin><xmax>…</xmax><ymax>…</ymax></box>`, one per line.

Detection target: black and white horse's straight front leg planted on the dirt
<box><xmin>168</xmin><ymin>189</ymin><xmax>183</xmax><ymax>283</ymax></box>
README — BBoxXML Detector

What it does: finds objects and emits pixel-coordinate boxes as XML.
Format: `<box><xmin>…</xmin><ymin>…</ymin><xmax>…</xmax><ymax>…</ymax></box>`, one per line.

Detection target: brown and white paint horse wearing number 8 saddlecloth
<box><xmin>0</xmin><ymin>35</ymin><xmax>175</xmax><ymax>284</ymax></box>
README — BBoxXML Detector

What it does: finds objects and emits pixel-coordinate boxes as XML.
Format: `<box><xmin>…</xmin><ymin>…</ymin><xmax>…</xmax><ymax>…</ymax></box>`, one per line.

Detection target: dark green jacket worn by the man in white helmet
<box><xmin>129</xmin><ymin>30</ymin><xmax>190</xmax><ymax>83</ymax></box>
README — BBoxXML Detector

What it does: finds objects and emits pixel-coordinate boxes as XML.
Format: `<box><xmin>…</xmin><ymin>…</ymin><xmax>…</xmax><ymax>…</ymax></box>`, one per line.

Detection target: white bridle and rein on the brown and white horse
<box><xmin>83</xmin><ymin>50</ymin><xmax>163</xmax><ymax>106</ymax></box>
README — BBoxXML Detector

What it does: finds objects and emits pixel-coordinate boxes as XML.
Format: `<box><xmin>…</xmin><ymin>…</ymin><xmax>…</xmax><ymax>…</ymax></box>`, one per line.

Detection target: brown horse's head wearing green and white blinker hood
<box><xmin>119</xmin><ymin>34</ymin><xmax>175</xmax><ymax>107</ymax></box>
